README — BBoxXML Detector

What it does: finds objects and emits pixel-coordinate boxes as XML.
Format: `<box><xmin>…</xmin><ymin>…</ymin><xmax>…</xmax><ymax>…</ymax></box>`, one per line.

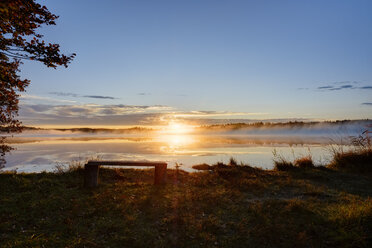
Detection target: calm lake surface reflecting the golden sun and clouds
<box><xmin>3</xmin><ymin>130</ymin><xmax>349</xmax><ymax>172</ymax></box>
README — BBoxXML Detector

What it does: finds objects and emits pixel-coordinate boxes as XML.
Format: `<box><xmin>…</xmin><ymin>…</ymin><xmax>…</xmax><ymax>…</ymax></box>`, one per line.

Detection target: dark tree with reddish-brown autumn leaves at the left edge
<box><xmin>0</xmin><ymin>0</ymin><xmax>75</xmax><ymax>166</ymax></box>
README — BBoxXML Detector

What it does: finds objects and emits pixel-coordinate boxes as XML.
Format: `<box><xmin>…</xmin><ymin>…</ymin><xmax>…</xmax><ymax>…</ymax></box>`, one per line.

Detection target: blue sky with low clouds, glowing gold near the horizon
<box><xmin>20</xmin><ymin>0</ymin><xmax>372</xmax><ymax>126</ymax></box>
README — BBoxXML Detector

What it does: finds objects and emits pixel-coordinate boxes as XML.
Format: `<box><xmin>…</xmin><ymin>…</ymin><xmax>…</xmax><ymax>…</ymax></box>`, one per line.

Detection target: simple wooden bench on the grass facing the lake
<box><xmin>84</xmin><ymin>160</ymin><xmax>167</xmax><ymax>188</ymax></box>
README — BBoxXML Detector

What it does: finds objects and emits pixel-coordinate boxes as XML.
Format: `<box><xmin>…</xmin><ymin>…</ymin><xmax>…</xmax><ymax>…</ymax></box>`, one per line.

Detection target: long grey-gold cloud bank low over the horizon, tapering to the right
<box><xmin>20</xmin><ymin>104</ymin><xmax>265</xmax><ymax>126</ymax></box>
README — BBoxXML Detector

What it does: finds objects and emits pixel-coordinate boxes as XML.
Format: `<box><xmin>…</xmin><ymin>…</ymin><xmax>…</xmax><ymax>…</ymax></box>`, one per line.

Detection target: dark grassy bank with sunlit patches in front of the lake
<box><xmin>0</xmin><ymin>165</ymin><xmax>372</xmax><ymax>247</ymax></box>
